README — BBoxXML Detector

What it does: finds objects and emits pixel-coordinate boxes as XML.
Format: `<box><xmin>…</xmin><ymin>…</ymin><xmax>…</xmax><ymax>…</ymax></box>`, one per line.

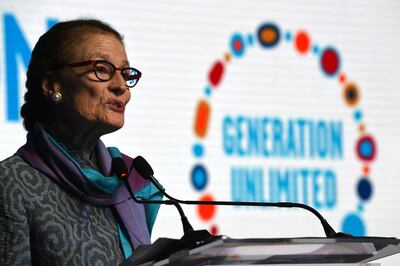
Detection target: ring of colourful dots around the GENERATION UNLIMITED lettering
<box><xmin>190</xmin><ymin>22</ymin><xmax>377</xmax><ymax>236</ymax></box>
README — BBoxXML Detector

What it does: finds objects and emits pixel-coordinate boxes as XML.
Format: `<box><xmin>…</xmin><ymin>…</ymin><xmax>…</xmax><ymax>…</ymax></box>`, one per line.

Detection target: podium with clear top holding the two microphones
<box><xmin>121</xmin><ymin>236</ymin><xmax>400</xmax><ymax>266</ymax></box>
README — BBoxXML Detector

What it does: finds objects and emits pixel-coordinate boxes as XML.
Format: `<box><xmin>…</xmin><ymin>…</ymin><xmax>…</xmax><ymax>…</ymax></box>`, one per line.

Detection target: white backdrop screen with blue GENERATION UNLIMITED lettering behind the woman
<box><xmin>0</xmin><ymin>0</ymin><xmax>400</xmax><ymax>265</ymax></box>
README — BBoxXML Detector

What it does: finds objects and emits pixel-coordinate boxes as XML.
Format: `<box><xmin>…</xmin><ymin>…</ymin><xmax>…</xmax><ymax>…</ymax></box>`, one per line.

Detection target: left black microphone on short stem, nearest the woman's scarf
<box><xmin>111</xmin><ymin>157</ymin><xmax>193</xmax><ymax>236</ymax></box>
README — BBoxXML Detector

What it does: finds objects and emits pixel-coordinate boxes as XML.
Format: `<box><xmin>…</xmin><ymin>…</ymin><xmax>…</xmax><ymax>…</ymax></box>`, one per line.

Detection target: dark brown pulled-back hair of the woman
<box><xmin>21</xmin><ymin>19</ymin><xmax>123</xmax><ymax>130</ymax></box>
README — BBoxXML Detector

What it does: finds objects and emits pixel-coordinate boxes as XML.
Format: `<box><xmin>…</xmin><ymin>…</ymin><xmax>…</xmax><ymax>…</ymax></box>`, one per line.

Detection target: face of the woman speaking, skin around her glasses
<box><xmin>60</xmin><ymin>34</ymin><xmax>131</xmax><ymax>135</ymax></box>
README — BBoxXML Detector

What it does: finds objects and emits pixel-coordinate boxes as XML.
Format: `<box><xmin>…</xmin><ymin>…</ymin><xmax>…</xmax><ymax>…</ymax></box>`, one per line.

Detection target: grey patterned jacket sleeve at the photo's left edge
<box><xmin>0</xmin><ymin>168</ymin><xmax>32</xmax><ymax>266</ymax></box>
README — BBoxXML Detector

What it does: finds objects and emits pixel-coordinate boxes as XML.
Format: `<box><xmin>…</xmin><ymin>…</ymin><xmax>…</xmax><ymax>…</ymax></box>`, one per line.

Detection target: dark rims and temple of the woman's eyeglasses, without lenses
<box><xmin>56</xmin><ymin>60</ymin><xmax>142</xmax><ymax>88</ymax></box>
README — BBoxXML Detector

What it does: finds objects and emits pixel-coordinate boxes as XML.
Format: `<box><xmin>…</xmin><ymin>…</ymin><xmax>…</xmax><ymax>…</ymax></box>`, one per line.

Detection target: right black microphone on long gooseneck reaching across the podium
<box><xmin>133</xmin><ymin>156</ymin><xmax>352</xmax><ymax>238</ymax></box>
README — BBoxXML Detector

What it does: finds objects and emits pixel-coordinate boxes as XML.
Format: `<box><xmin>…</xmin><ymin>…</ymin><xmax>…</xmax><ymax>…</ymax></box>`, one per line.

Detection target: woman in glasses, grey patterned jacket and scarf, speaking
<box><xmin>0</xmin><ymin>19</ymin><xmax>161</xmax><ymax>265</ymax></box>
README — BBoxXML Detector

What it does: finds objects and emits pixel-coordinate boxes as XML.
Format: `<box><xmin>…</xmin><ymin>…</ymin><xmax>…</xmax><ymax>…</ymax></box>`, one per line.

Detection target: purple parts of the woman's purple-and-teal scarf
<box><xmin>17</xmin><ymin>124</ymin><xmax>150</xmax><ymax>248</ymax></box>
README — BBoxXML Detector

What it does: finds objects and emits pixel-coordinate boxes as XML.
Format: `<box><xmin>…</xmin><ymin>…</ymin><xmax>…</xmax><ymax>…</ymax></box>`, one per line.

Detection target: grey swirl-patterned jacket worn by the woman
<box><xmin>0</xmin><ymin>156</ymin><xmax>123</xmax><ymax>265</ymax></box>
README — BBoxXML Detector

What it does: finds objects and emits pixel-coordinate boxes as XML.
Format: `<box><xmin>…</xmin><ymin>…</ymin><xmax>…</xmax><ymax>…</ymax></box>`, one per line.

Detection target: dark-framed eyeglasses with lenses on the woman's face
<box><xmin>58</xmin><ymin>60</ymin><xmax>142</xmax><ymax>88</ymax></box>
